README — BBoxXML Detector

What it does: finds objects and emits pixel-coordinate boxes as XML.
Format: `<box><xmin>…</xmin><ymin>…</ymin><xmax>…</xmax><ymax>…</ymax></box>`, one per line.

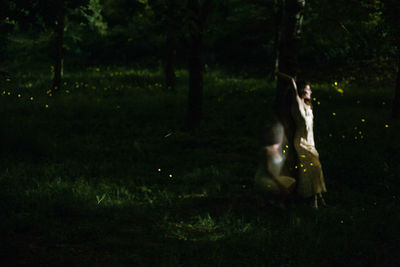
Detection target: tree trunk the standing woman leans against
<box><xmin>275</xmin><ymin>0</ymin><xmax>305</xmax><ymax>180</ymax></box>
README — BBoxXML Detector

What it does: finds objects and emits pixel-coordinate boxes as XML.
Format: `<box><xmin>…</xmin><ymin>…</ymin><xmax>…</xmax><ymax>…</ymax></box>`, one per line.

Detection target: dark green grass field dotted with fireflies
<box><xmin>0</xmin><ymin>66</ymin><xmax>400</xmax><ymax>266</ymax></box>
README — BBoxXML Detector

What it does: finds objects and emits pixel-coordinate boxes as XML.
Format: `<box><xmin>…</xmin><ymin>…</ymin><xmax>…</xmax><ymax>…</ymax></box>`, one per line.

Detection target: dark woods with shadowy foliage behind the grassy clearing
<box><xmin>0</xmin><ymin>0</ymin><xmax>399</xmax><ymax>129</ymax></box>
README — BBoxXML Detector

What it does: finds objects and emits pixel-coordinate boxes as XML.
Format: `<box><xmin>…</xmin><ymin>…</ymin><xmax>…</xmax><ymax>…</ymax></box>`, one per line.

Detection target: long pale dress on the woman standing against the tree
<box><xmin>291</xmin><ymin>94</ymin><xmax>326</xmax><ymax>197</ymax></box>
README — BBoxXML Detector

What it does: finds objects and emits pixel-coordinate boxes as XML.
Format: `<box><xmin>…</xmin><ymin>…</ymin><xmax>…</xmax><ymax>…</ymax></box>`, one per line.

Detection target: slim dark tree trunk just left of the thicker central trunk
<box><xmin>164</xmin><ymin>30</ymin><xmax>176</xmax><ymax>91</ymax></box>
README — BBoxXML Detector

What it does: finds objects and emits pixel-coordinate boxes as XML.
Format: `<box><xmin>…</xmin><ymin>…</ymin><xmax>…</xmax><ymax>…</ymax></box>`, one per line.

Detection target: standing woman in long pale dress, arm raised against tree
<box><xmin>277</xmin><ymin>72</ymin><xmax>326</xmax><ymax>208</ymax></box>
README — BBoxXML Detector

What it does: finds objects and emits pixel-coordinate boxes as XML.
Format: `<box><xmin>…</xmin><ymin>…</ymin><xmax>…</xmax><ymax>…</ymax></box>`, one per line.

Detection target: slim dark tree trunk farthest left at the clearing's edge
<box><xmin>53</xmin><ymin>3</ymin><xmax>65</xmax><ymax>91</ymax></box>
